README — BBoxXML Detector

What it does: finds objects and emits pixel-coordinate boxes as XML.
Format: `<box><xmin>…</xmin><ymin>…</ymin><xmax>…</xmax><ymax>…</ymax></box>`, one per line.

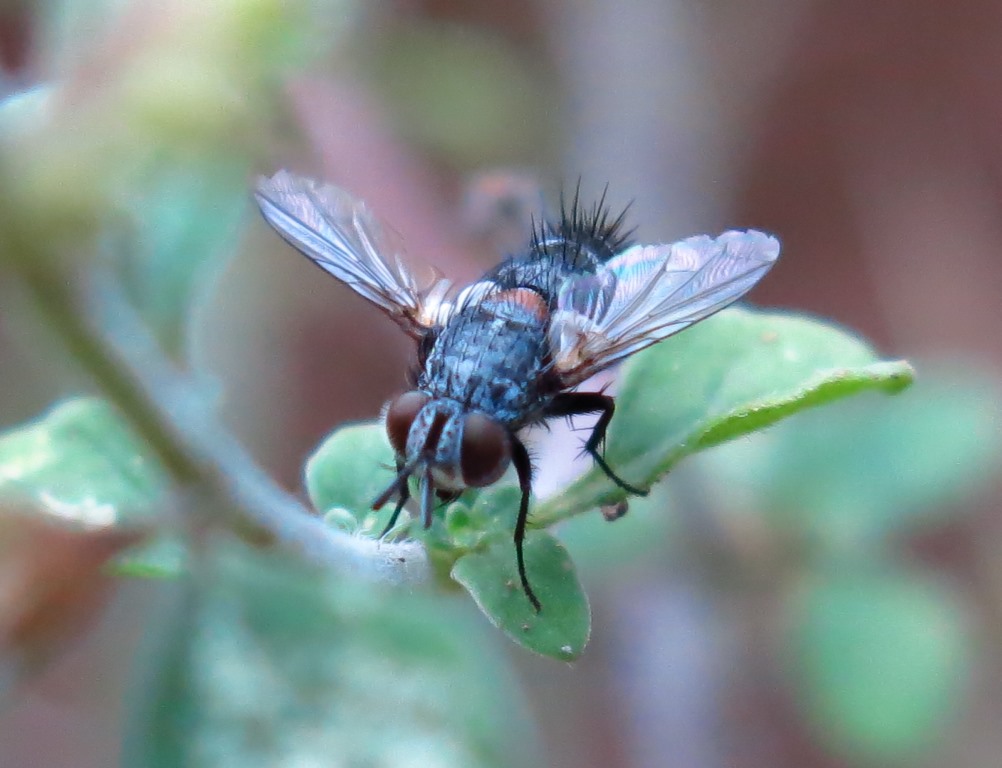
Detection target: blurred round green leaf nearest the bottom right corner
<box><xmin>789</xmin><ymin>568</ymin><xmax>972</xmax><ymax>764</ymax></box>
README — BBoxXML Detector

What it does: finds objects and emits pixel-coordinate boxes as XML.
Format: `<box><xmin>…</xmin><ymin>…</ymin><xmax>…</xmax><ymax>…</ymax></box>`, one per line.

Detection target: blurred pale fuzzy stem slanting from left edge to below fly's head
<box><xmin>12</xmin><ymin>258</ymin><xmax>427</xmax><ymax>582</ymax></box>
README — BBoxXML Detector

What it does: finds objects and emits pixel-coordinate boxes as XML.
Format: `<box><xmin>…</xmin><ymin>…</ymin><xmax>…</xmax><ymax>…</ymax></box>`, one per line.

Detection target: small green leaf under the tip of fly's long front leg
<box><xmin>452</xmin><ymin>531</ymin><xmax>591</xmax><ymax>661</ymax></box>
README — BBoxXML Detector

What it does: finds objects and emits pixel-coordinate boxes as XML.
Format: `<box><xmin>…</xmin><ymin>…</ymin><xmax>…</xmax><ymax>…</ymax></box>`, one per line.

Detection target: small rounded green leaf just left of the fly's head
<box><xmin>306</xmin><ymin>421</ymin><xmax>396</xmax><ymax>533</ymax></box>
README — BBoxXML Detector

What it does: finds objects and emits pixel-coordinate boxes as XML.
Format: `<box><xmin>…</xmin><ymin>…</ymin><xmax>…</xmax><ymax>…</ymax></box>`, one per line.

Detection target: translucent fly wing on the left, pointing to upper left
<box><xmin>255</xmin><ymin>170</ymin><xmax>451</xmax><ymax>338</ymax></box>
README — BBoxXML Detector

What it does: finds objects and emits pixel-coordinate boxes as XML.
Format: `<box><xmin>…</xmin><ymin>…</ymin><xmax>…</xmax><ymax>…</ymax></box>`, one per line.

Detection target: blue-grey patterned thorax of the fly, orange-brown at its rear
<box><xmin>418</xmin><ymin>289</ymin><xmax>549</xmax><ymax>429</ymax></box>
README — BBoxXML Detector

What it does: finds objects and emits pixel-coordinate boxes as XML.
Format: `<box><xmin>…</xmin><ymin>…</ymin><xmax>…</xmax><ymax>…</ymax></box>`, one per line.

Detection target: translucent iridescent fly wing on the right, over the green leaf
<box><xmin>549</xmin><ymin>230</ymin><xmax>780</xmax><ymax>386</ymax></box>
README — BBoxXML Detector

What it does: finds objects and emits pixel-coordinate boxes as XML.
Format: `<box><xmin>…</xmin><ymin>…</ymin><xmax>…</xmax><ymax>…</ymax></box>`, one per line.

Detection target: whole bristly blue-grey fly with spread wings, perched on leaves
<box><xmin>256</xmin><ymin>170</ymin><xmax>780</xmax><ymax>611</ymax></box>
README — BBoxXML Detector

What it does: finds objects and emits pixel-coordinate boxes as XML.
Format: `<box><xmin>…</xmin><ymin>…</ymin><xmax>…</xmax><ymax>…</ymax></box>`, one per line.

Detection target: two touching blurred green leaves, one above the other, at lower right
<box><xmin>699</xmin><ymin>376</ymin><xmax>1002</xmax><ymax>764</ymax></box>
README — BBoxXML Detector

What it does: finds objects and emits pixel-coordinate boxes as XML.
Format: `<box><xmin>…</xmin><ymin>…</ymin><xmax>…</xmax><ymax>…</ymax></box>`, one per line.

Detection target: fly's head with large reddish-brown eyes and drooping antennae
<box><xmin>374</xmin><ymin>390</ymin><xmax>511</xmax><ymax>527</ymax></box>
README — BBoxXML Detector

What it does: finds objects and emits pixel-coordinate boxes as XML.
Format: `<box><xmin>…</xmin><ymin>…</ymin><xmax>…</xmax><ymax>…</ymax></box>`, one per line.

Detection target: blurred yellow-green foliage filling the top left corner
<box><xmin>0</xmin><ymin>0</ymin><xmax>344</xmax><ymax>348</ymax></box>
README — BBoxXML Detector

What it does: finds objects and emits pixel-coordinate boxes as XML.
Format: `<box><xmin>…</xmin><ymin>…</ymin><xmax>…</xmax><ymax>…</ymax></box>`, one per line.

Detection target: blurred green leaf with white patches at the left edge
<box><xmin>0</xmin><ymin>398</ymin><xmax>166</xmax><ymax>527</ymax></box>
